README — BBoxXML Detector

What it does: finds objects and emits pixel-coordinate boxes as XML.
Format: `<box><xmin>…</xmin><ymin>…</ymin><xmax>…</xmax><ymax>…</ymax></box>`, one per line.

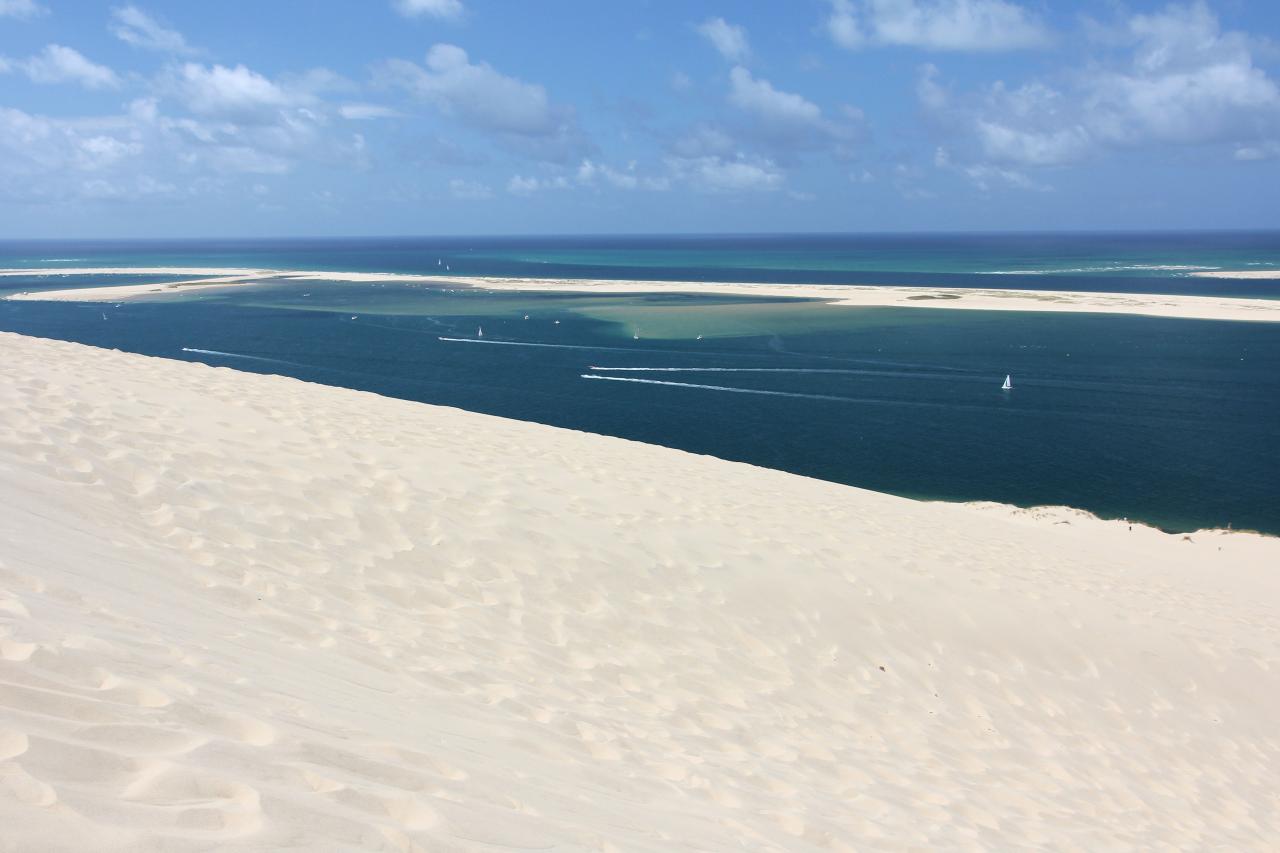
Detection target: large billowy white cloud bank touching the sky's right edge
<box><xmin>916</xmin><ymin>3</ymin><xmax>1280</xmax><ymax>171</ymax></box>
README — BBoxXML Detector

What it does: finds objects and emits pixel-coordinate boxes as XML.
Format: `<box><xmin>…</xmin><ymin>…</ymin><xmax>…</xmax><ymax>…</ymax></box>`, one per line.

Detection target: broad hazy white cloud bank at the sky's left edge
<box><xmin>0</xmin><ymin>58</ymin><xmax>370</xmax><ymax>204</ymax></box>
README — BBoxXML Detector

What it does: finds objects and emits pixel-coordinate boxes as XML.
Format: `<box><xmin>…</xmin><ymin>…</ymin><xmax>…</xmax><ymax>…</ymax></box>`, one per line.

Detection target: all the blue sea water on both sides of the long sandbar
<box><xmin>0</xmin><ymin>233</ymin><xmax>1280</xmax><ymax>534</ymax></box>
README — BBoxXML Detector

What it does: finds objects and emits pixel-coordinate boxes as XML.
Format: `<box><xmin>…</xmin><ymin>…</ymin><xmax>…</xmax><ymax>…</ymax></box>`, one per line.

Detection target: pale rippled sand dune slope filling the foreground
<box><xmin>0</xmin><ymin>334</ymin><xmax>1280</xmax><ymax>853</ymax></box>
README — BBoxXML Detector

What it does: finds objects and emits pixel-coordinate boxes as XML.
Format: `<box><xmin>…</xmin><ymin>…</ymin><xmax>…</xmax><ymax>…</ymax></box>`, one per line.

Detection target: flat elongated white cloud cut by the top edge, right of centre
<box><xmin>826</xmin><ymin>0</ymin><xmax>1048</xmax><ymax>51</ymax></box>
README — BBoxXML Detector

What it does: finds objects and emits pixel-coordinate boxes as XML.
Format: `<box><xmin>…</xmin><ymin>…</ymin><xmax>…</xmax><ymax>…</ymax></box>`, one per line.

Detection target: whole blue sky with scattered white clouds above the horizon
<box><xmin>0</xmin><ymin>0</ymin><xmax>1280</xmax><ymax>238</ymax></box>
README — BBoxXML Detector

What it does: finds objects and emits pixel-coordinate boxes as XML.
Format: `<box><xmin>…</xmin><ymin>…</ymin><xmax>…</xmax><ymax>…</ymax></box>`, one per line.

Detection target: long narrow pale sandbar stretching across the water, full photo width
<box><xmin>0</xmin><ymin>268</ymin><xmax>1280</xmax><ymax>323</ymax></box>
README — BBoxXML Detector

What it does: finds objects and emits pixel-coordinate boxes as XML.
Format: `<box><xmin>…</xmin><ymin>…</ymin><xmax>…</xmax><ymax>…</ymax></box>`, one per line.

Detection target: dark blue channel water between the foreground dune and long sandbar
<box><xmin>0</xmin><ymin>245</ymin><xmax>1280</xmax><ymax>534</ymax></box>
